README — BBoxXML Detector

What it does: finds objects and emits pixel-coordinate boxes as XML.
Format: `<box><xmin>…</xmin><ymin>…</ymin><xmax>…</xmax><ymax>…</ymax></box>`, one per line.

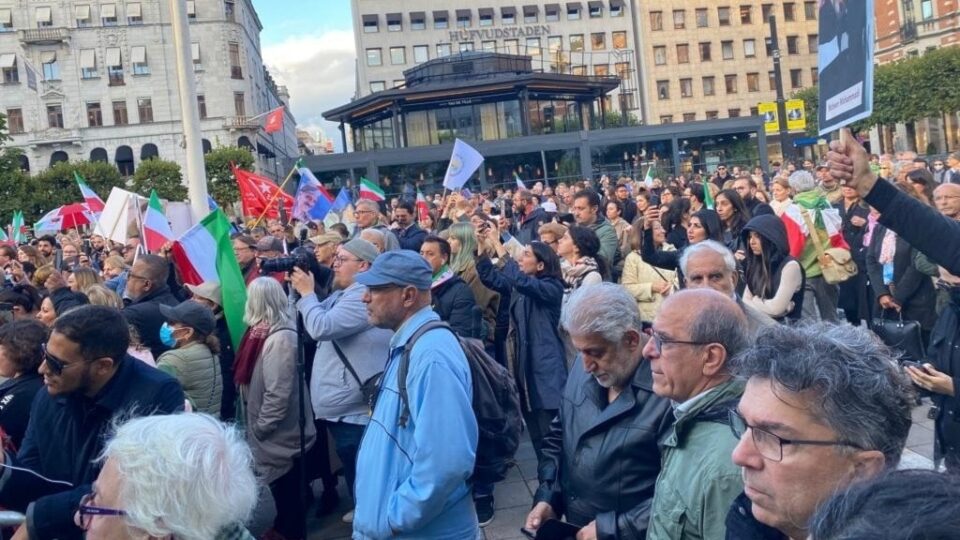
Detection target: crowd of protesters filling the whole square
<box><xmin>0</xmin><ymin>134</ymin><xmax>960</xmax><ymax>540</ymax></box>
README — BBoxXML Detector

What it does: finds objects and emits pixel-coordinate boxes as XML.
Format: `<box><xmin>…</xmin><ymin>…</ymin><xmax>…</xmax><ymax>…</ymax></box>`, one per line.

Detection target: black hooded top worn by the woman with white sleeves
<box><xmin>740</xmin><ymin>214</ymin><xmax>806</xmax><ymax>320</ymax></box>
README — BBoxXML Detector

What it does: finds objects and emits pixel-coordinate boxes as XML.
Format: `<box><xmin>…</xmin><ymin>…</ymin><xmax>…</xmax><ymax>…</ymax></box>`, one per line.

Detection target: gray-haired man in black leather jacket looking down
<box><xmin>525</xmin><ymin>283</ymin><xmax>672</xmax><ymax>540</ymax></box>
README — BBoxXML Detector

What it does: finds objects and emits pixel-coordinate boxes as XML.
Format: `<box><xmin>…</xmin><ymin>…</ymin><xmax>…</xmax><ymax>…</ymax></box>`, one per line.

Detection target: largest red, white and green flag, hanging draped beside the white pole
<box><xmin>173</xmin><ymin>210</ymin><xmax>247</xmax><ymax>350</ymax></box>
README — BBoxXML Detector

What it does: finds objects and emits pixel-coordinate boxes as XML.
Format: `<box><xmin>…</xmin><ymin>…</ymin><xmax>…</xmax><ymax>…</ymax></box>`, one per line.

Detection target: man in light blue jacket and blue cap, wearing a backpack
<box><xmin>353</xmin><ymin>250</ymin><xmax>480</xmax><ymax>540</ymax></box>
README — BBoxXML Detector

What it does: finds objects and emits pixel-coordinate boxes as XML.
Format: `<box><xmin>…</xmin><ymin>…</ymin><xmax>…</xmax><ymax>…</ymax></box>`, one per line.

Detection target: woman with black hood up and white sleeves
<box><xmin>742</xmin><ymin>214</ymin><xmax>804</xmax><ymax>322</ymax></box>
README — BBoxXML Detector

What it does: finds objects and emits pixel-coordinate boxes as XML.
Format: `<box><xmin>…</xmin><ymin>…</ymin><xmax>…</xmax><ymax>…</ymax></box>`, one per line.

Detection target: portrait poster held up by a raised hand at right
<box><xmin>818</xmin><ymin>0</ymin><xmax>874</xmax><ymax>135</ymax></box>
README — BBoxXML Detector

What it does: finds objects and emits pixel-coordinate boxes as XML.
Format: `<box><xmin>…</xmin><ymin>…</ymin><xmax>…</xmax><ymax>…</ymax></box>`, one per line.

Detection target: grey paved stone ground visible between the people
<box><xmin>308</xmin><ymin>401</ymin><xmax>933</xmax><ymax>540</ymax></box>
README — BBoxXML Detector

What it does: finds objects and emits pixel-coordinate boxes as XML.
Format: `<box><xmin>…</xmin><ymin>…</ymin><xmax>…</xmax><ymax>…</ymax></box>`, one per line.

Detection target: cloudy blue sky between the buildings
<box><xmin>253</xmin><ymin>0</ymin><xmax>357</xmax><ymax>151</ymax></box>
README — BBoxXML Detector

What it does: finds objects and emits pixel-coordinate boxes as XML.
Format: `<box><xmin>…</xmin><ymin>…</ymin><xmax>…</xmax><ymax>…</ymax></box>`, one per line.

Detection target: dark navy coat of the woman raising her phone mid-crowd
<box><xmin>477</xmin><ymin>257</ymin><xmax>567</xmax><ymax>411</ymax></box>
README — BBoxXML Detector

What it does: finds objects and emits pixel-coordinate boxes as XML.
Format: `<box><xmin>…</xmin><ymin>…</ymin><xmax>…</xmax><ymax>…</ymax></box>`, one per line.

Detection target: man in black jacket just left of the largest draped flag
<box><xmin>123</xmin><ymin>255</ymin><xmax>180</xmax><ymax>358</ymax></box>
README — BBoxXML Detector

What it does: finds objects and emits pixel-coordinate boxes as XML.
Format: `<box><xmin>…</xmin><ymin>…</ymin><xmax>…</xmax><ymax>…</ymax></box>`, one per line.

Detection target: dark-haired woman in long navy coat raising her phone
<box><xmin>477</xmin><ymin>227</ymin><xmax>567</xmax><ymax>462</ymax></box>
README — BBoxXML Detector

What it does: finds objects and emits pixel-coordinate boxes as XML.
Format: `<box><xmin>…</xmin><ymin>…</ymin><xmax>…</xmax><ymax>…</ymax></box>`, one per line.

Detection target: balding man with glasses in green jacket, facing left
<box><xmin>643</xmin><ymin>289</ymin><xmax>748</xmax><ymax>540</ymax></box>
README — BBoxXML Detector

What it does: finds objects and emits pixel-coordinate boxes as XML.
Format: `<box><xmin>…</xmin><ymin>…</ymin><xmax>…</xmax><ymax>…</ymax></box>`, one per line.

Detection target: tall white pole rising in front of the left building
<box><xmin>169</xmin><ymin>0</ymin><xmax>210</xmax><ymax>221</ymax></box>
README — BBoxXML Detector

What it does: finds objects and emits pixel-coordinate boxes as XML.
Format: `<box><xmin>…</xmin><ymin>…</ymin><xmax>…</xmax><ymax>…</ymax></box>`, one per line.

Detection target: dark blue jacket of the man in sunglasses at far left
<box><xmin>0</xmin><ymin>356</ymin><xmax>184</xmax><ymax>540</ymax></box>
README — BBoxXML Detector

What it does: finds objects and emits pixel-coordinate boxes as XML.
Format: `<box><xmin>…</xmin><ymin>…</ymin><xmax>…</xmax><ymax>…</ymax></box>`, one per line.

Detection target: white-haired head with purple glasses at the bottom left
<box><xmin>74</xmin><ymin>413</ymin><xmax>257</xmax><ymax>540</ymax></box>
